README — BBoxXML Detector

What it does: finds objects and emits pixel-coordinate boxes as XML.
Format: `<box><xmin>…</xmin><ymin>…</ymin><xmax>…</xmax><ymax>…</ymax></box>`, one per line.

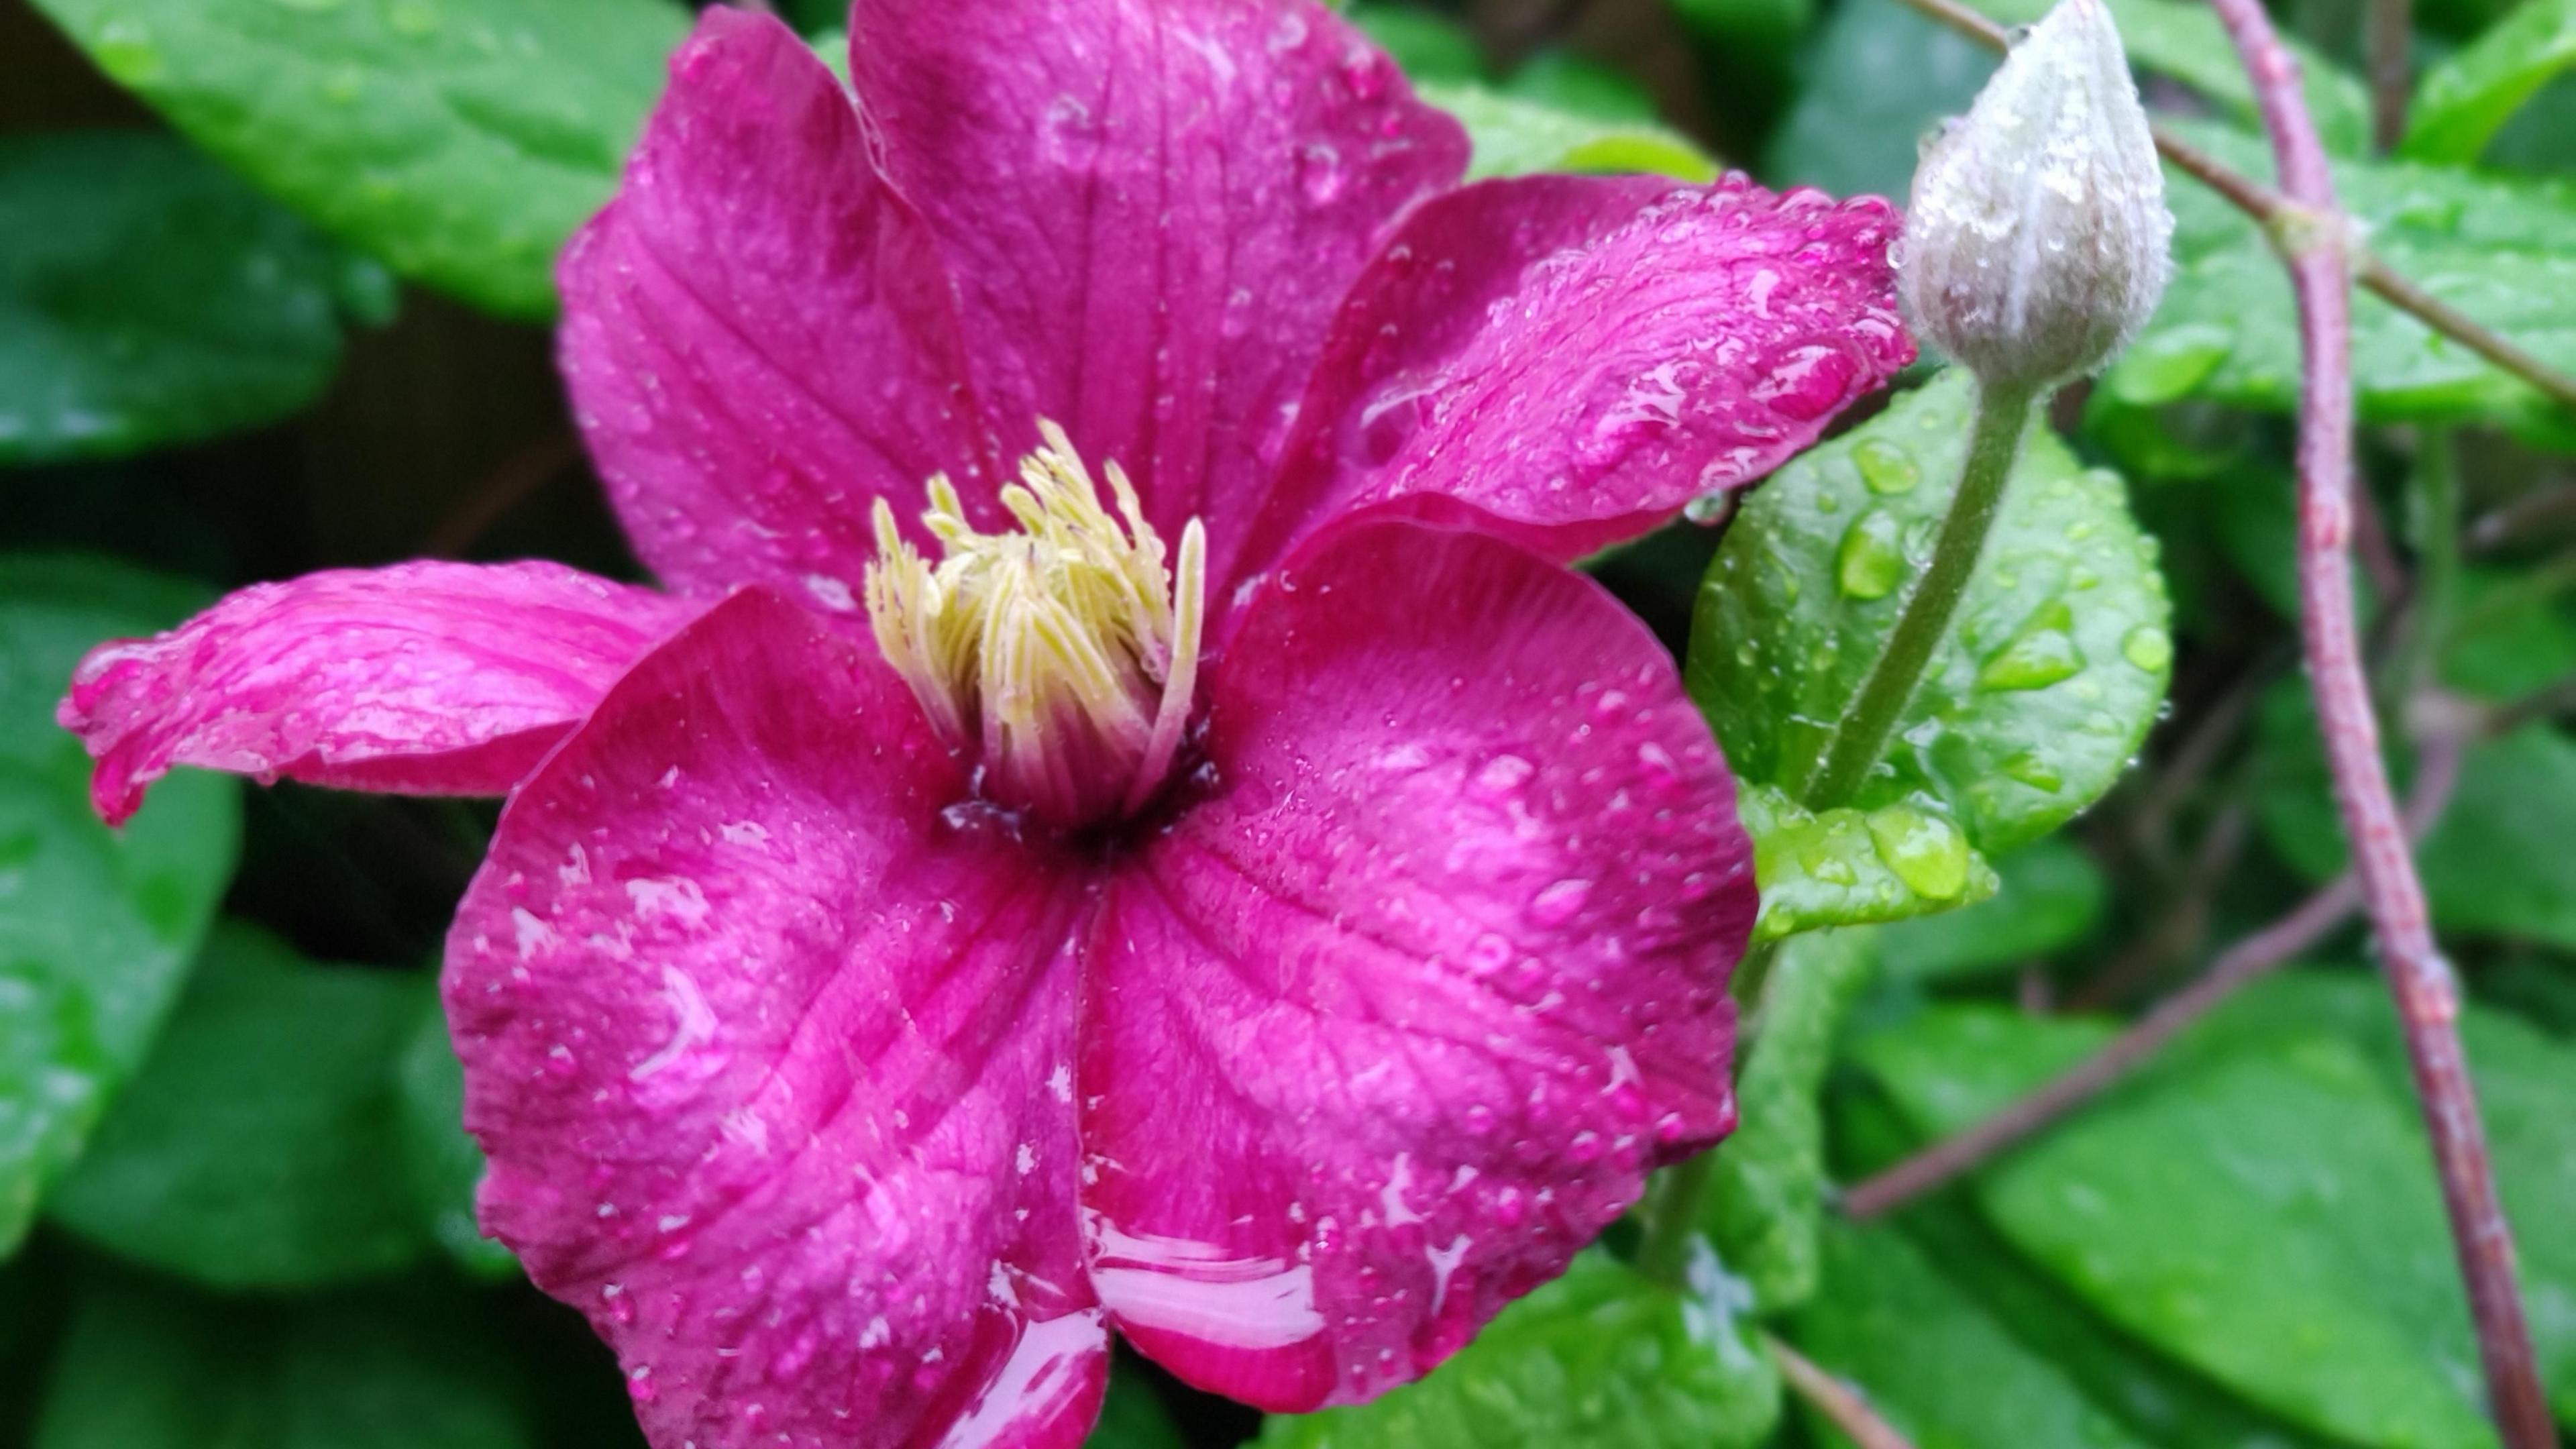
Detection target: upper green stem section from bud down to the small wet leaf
<box><xmin>1798</xmin><ymin>382</ymin><xmax>2033</xmax><ymax>810</ymax></box>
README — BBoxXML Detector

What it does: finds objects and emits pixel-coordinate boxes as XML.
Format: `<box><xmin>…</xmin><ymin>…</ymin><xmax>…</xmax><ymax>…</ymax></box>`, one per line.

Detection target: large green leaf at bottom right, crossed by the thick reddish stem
<box><xmin>1858</xmin><ymin>972</ymin><xmax>2576</xmax><ymax>1449</ymax></box>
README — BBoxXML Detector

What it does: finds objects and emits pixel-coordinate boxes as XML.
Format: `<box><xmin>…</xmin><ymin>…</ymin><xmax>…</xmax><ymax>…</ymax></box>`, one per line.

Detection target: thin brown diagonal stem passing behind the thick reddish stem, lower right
<box><xmin>1842</xmin><ymin>737</ymin><xmax>2460</xmax><ymax>1220</ymax></box>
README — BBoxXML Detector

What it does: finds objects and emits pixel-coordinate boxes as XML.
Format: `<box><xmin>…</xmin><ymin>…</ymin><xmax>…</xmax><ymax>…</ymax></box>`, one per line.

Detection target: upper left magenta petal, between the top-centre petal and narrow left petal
<box><xmin>559</xmin><ymin>5</ymin><xmax>991</xmax><ymax>598</ymax></box>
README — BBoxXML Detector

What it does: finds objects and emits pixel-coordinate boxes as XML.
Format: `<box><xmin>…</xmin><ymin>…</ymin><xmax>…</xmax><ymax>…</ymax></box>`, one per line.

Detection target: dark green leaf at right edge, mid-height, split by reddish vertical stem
<box><xmin>2254</xmin><ymin>681</ymin><xmax>2576</xmax><ymax>947</ymax></box>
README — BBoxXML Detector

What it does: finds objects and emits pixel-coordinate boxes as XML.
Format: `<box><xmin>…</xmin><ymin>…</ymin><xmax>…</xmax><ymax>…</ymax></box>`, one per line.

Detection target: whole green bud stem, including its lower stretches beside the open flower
<box><xmin>1635</xmin><ymin>374</ymin><xmax>2037</xmax><ymax>1287</ymax></box>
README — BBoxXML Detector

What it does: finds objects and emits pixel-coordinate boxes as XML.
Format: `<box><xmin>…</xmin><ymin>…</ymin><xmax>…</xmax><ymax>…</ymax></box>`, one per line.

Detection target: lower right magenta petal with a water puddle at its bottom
<box><xmin>1082</xmin><ymin>521</ymin><xmax>1754</xmax><ymax>1410</ymax></box>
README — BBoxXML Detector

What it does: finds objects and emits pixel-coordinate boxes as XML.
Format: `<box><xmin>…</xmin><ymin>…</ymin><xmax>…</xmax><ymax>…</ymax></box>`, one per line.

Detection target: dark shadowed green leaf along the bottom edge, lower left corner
<box><xmin>34</xmin><ymin>1276</ymin><xmax>536</xmax><ymax>1449</ymax></box>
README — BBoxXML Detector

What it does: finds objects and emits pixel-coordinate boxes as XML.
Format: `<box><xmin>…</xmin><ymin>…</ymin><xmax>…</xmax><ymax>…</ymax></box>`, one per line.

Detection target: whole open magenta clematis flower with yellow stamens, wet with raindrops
<box><xmin>62</xmin><ymin>0</ymin><xmax>1911</xmax><ymax>1449</ymax></box>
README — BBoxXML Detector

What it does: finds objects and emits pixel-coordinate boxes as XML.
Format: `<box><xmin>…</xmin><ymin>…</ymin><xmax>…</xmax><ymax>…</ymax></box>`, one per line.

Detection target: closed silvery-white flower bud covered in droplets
<box><xmin>1898</xmin><ymin>0</ymin><xmax>2174</xmax><ymax>389</ymax></box>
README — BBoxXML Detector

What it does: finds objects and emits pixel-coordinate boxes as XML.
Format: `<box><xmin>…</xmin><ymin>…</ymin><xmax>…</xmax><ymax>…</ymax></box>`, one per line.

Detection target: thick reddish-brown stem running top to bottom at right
<box><xmin>2210</xmin><ymin>0</ymin><xmax>2558</xmax><ymax>1449</ymax></box>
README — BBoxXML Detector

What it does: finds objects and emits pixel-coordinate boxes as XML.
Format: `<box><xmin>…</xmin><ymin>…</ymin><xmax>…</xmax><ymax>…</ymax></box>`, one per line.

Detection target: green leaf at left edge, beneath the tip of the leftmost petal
<box><xmin>0</xmin><ymin>557</ymin><xmax>242</xmax><ymax>1258</ymax></box>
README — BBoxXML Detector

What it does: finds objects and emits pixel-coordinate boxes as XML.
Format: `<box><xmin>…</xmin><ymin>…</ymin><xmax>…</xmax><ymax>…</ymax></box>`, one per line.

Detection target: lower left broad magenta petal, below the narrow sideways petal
<box><xmin>445</xmin><ymin>590</ymin><xmax>1108</xmax><ymax>1449</ymax></box>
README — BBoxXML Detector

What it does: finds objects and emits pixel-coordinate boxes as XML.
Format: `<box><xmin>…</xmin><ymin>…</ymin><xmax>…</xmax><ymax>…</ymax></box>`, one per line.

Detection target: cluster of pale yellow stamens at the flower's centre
<box><xmin>868</xmin><ymin>420</ymin><xmax>1208</xmax><ymax>825</ymax></box>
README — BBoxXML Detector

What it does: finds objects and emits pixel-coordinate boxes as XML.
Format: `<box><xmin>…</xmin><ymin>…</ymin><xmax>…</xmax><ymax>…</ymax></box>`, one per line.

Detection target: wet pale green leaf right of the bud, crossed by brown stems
<box><xmin>2104</xmin><ymin>121</ymin><xmax>2576</xmax><ymax>449</ymax></box>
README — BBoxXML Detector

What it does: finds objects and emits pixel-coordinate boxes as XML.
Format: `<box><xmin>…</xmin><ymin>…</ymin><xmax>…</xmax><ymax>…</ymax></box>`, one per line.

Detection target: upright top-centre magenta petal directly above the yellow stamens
<box><xmin>850</xmin><ymin>0</ymin><xmax>1466</xmax><ymax>539</ymax></box>
